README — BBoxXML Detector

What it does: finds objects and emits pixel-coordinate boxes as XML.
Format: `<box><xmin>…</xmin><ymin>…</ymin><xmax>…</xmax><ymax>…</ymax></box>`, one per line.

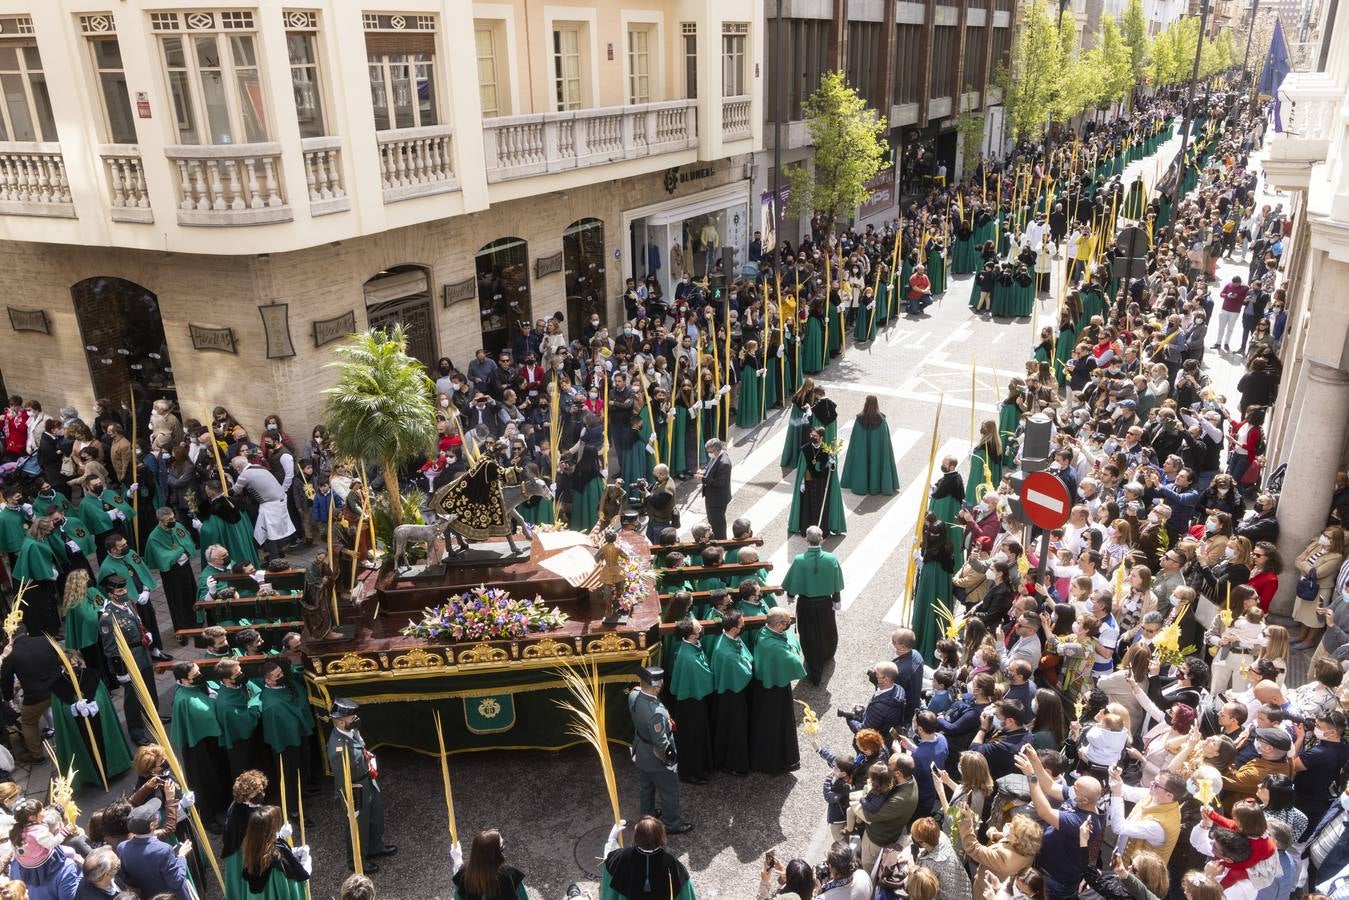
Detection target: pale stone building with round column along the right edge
<box><xmin>1264</xmin><ymin>4</ymin><xmax>1349</xmax><ymax>613</ymax></box>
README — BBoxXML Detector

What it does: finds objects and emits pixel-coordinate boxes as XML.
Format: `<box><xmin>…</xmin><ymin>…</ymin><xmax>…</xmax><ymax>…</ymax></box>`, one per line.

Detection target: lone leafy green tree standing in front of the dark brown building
<box><xmin>786</xmin><ymin>72</ymin><xmax>886</xmax><ymax>235</ymax></box>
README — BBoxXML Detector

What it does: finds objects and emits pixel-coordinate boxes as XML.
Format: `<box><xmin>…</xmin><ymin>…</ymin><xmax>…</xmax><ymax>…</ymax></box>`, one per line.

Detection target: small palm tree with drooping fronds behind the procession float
<box><xmin>324</xmin><ymin>325</ymin><xmax>436</xmax><ymax>525</ymax></box>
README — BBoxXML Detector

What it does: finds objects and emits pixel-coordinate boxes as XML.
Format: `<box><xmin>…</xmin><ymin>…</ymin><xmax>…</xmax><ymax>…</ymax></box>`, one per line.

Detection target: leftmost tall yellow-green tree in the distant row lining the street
<box><xmin>997</xmin><ymin>0</ymin><xmax>1063</xmax><ymax>140</ymax></box>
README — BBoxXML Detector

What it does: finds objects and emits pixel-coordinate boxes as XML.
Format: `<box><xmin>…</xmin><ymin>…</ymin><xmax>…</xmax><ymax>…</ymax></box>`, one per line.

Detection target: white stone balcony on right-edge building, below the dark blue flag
<box><xmin>1265</xmin><ymin>72</ymin><xmax>1345</xmax><ymax>190</ymax></box>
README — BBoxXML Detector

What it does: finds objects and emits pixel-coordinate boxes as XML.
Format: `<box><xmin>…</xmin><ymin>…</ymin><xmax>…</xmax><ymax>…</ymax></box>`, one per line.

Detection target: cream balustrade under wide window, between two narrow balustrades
<box><xmin>165</xmin><ymin>143</ymin><xmax>291</xmax><ymax>225</ymax></box>
